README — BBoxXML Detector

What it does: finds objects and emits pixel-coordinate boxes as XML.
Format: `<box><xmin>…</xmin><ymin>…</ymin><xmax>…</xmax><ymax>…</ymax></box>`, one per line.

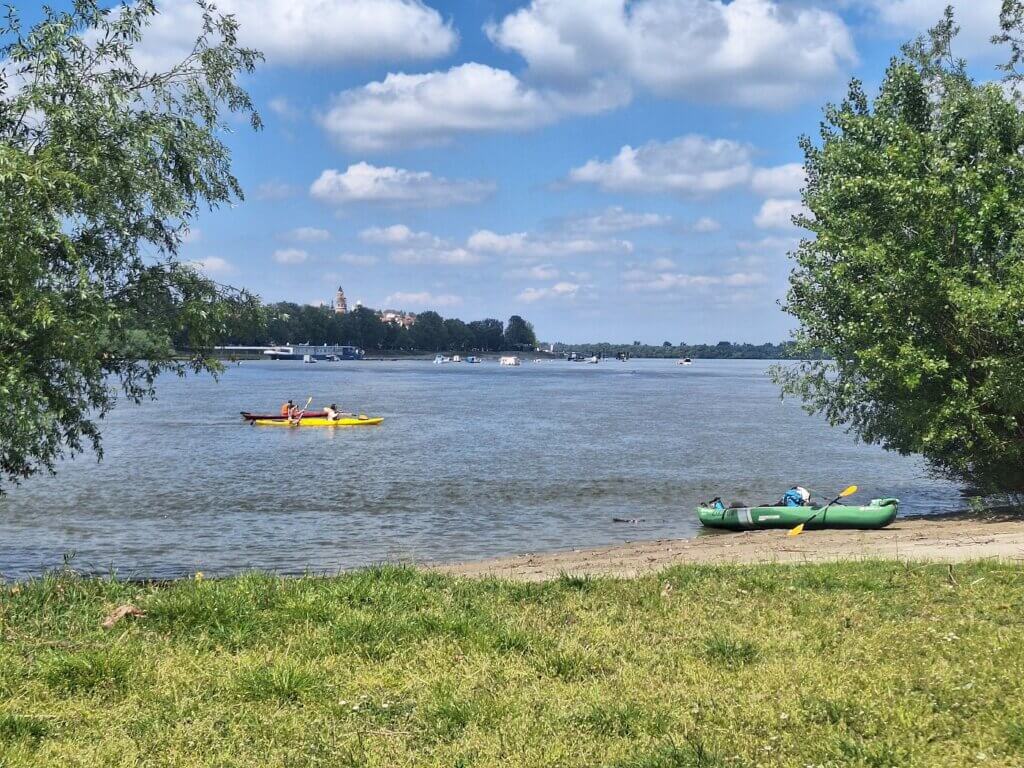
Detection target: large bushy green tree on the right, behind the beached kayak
<box><xmin>775</xmin><ymin>7</ymin><xmax>1024</xmax><ymax>490</ymax></box>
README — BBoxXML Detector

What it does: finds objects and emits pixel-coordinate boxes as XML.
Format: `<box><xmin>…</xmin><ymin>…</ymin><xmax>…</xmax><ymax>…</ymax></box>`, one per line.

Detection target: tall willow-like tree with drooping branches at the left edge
<box><xmin>0</xmin><ymin>0</ymin><xmax>259</xmax><ymax>489</ymax></box>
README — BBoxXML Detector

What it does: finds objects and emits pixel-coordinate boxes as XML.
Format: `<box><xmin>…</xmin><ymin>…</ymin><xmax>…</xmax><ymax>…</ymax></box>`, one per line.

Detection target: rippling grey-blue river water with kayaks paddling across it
<box><xmin>0</xmin><ymin>360</ymin><xmax>964</xmax><ymax>579</ymax></box>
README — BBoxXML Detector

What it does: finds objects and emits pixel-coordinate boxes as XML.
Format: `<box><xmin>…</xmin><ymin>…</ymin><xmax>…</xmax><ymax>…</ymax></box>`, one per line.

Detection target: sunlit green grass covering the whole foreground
<box><xmin>0</xmin><ymin>562</ymin><xmax>1024</xmax><ymax>768</ymax></box>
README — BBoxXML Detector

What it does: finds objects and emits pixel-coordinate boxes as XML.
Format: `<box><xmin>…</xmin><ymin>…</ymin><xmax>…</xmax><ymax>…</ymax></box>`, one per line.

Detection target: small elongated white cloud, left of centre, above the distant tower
<box><xmin>309</xmin><ymin>163</ymin><xmax>495</xmax><ymax>207</ymax></box>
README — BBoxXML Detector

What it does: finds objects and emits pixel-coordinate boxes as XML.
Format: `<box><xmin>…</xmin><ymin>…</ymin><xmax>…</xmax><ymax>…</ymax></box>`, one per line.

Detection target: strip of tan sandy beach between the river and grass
<box><xmin>432</xmin><ymin>515</ymin><xmax>1024</xmax><ymax>581</ymax></box>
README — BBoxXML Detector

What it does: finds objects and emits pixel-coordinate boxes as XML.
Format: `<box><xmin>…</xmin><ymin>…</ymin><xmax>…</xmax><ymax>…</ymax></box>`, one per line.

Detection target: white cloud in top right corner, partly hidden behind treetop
<box><xmin>861</xmin><ymin>0</ymin><xmax>1001</xmax><ymax>55</ymax></box>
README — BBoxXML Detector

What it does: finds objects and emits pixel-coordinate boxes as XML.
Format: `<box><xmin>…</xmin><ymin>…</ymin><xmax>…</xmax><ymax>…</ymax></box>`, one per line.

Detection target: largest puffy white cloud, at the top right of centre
<box><xmin>486</xmin><ymin>0</ymin><xmax>856</xmax><ymax>108</ymax></box>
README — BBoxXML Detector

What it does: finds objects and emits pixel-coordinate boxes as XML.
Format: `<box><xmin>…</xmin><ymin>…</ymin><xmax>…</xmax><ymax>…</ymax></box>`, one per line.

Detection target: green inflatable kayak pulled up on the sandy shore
<box><xmin>697</xmin><ymin>499</ymin><xmax>899</xmax><ymax>530</ymax></box>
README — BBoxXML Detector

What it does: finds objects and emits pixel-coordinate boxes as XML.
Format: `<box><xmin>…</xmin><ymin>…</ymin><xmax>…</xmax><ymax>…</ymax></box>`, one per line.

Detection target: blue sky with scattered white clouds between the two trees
<box><xmin>14</xmin><ymin>0</ymin><xmax>1001</xmax><ymax>344</ymax></box>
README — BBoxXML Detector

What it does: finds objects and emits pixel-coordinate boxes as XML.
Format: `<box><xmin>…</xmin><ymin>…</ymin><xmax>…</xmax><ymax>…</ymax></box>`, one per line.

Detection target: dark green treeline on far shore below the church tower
<box><xmin>222</xmin><ymin>302</ymin><xmax>537</xmax><ymax>352</ymax></box>
